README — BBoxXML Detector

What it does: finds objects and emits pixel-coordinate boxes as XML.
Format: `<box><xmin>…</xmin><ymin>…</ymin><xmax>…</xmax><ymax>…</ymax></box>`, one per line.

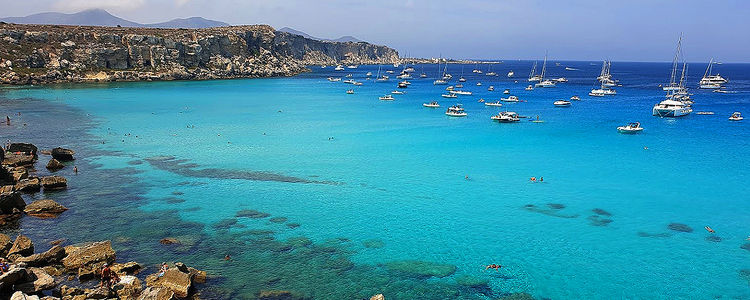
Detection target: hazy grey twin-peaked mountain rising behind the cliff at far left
<box><xmin>0</xmin><ymin>9</ymin><xmax>229</xmax><ymax>28</ymax></box>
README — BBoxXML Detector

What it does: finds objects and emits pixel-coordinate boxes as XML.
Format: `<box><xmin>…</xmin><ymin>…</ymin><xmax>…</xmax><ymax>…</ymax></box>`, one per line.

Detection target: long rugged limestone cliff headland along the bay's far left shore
<box><xmin>0</xmin><ymin>24</ymin><xmax>398</xmax><ymax>84</ymax></box>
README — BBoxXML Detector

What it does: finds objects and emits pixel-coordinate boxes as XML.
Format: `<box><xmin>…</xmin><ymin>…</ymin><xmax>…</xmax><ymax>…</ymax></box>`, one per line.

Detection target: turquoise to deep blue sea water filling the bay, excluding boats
<box><xmin>0</xmin><ymin>61</ymin><xmax>750</xmax><ymax>299</ymax></box>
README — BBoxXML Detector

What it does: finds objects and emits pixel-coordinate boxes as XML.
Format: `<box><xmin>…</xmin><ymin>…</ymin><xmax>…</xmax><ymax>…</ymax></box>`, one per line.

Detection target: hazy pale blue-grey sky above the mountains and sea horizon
<box><xmin>0</xmin><ymin>0</ymin><xmax>750</xmax><ymax>62</ymax></box>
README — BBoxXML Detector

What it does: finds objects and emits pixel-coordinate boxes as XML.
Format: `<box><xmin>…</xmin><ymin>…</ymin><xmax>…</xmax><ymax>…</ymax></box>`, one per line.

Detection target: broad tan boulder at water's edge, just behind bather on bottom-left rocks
<box><xmin>62</xmin><ymin>241</ymin><xmax>115</xmax><ymax>271</ymax></box>
